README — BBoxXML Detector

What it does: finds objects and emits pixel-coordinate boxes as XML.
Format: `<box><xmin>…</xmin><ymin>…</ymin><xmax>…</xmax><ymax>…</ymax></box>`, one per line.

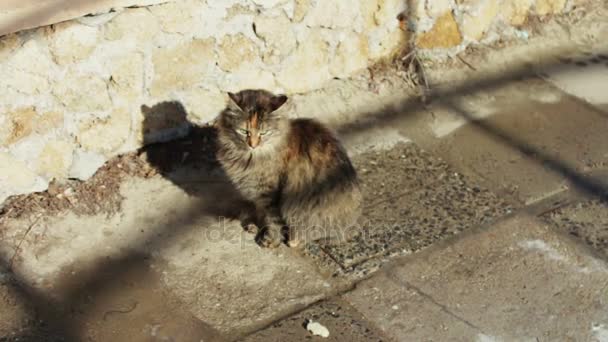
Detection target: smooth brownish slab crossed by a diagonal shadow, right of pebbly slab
<box><xmin>423</xmin><ymin>79</ymin><xmax>608</xmax><ymax>205</ymax></box>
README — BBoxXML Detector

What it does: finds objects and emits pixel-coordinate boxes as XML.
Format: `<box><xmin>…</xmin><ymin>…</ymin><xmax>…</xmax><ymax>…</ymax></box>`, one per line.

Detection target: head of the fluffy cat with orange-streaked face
<box><xmin>219</xmin><ymin>90</ymin><xmax>287</xmax><ymax>151</ymax></box>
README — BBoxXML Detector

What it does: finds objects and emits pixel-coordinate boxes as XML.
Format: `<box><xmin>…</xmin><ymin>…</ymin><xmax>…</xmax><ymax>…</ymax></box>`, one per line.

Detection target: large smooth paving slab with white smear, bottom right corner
<box><xmin>344</xmin><ymin>215</ymin><xmax>608</xmax><ymax>341</ymax></box>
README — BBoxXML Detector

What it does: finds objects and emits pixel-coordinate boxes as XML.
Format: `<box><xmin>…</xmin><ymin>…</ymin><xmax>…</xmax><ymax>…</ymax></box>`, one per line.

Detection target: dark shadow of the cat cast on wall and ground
<box><xmin>139</xmin><ymin>101</ymin><xmax>251</xmax><ymax>224</ymax></box>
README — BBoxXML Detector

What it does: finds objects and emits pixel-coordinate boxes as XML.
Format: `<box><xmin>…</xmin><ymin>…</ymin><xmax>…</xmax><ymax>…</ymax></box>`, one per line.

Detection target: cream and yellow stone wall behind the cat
<box><xmin>0</xmin><ymin>0</ymin><xmax>582</xmax><ymax>204</ymax></box>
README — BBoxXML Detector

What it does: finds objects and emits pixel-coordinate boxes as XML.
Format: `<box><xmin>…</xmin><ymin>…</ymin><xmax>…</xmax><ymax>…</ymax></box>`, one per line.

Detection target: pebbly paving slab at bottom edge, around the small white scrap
<box><xmin>243</xmin><ymin>298</ymin><xmax>387</xmax><ymax>342</ymax></box>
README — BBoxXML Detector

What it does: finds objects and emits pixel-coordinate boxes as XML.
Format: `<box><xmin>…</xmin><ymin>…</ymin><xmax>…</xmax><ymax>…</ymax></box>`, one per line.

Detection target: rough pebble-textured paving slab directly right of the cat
<box><xmin>308</xmin><ymin>143</ymin><xmax>513</xmax><ymax>277</ymax></box>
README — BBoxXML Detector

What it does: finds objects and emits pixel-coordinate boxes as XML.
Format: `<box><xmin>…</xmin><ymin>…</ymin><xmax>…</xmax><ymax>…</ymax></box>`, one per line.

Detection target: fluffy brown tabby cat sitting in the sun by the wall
<box><xmin>215</xmin><ymin>89</ymin><xmax>362</xmax><ymax>248</ymax></box>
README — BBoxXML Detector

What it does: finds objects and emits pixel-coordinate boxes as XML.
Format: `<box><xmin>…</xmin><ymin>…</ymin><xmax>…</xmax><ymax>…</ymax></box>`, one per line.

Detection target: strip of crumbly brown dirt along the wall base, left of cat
<box><xmin>0</xmin><ymin>126</ymin><xmax>217</xmax><ymax>223</ymax></box>
